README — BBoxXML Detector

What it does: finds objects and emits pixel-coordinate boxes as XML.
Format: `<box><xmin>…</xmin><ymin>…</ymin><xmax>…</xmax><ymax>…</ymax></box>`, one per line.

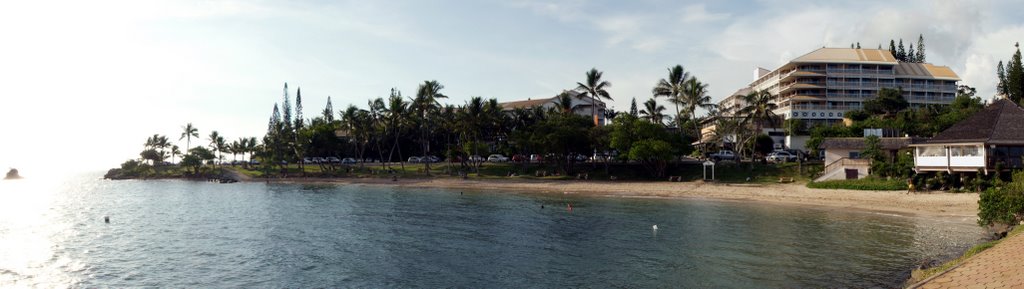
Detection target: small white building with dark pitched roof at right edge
<box><xmin>911</xmin><ymin>99</ymin><xmax>1024</xmax><ymax>174</ymax></box>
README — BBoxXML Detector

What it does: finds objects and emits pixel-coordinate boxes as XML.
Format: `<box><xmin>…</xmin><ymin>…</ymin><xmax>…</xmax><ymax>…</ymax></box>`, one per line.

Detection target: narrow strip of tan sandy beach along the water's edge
<box><xmin>253</xmin><ymin>174</ymin><xmax>978</xmax><ymax>221</ymax></box>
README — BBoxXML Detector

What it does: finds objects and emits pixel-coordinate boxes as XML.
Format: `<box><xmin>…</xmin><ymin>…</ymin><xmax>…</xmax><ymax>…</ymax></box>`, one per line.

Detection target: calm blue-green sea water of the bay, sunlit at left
<box><xmin>0</xmin><ymin>174</ymin><xmax>983</xmax><ymax>288</ymax></box>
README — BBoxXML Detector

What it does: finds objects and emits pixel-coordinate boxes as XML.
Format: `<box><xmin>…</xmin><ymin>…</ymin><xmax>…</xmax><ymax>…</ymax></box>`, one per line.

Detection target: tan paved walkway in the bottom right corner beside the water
<box><xmin>913</xmin><ymin>234</ymin><xmax>1024</xmax><ymax>288</ymax></box>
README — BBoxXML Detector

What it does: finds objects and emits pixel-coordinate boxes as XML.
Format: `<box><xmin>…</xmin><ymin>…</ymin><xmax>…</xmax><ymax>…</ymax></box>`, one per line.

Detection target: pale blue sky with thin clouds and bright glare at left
<box><xmin>0</xmin><ymin>0</ymin><xmax>1024</xmax><ymax>171</ymax></box>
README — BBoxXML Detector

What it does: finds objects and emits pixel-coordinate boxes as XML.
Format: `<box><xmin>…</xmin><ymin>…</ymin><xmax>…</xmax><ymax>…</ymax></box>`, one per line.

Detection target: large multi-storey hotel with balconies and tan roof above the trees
<box><xmin>719</xmin><ymin>48</ymin><xmax>959</xmax><ymax>126</ymax></box>
